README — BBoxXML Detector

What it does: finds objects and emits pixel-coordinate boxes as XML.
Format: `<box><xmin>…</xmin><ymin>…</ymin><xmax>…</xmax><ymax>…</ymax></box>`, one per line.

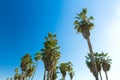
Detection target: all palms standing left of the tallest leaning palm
<box><xmin>7</xmin><ymin>33</ymin><xmax>74</xmax><ymax>80</ymax></box>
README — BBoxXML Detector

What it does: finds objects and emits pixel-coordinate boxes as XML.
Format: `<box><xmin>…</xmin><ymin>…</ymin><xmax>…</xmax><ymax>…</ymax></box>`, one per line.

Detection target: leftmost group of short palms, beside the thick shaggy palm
<box><xmin>7</xmin><ymin>52</ymin><xmax>42</xmax><ymax>80</ymax></box>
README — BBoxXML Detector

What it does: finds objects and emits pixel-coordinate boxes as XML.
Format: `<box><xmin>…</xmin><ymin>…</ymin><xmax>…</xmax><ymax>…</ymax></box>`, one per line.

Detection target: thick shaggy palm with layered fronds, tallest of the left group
<box><xmin>41</xmin><ymin>33</ymin><xmax>60</xmax><ymax>80</ymax></box>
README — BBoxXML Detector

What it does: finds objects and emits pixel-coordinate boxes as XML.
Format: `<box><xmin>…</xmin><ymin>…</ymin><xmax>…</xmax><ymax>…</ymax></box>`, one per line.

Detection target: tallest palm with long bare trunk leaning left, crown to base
<box><xmin>74</xmin><ymin>8</ymin><xmax>99</xmax><ymax>80</ymax></box>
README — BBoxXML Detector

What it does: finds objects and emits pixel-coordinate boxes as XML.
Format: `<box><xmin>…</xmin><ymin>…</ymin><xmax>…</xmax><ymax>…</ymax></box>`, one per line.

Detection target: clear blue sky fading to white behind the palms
<box><xmin>0</xmin><ymin>0</ymin><xmax>120</xmax><ymax>80</ymax></box>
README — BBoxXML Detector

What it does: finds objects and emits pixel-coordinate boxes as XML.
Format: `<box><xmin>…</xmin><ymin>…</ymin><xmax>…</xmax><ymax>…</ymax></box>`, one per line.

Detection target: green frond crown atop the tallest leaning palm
<box><xmin>74</xmin><ymin>8</ymin><xmax>94</xmax><ymax>38</ymax></box>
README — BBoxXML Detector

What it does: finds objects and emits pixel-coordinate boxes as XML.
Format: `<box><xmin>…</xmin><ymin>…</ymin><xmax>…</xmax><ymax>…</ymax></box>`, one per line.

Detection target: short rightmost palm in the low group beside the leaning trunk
<box><xmin>102</xmin><ymin>52</ymin><xmax>112</xmax><ymax>80</ymax></box>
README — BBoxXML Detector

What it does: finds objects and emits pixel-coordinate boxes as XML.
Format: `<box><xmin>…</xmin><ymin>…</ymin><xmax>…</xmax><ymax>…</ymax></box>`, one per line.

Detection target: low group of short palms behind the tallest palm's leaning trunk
<box><xmin>85</xmin><ymin>52</ymin><xmax>111</xmax><ymax>80</ymax></box>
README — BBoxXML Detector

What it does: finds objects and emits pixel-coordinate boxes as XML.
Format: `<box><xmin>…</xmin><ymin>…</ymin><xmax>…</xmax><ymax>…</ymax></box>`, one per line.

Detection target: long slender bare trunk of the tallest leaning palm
<box><xmin>86</xmin><ymin>37</ymin><xmax>99</xmax><ymax>80</ymax></box>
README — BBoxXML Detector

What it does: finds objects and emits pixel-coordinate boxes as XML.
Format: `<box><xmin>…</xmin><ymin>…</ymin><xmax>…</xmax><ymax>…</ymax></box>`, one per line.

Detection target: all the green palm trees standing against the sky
<box><xmin>7</xmin><ymin>8</ymin><xmax>111</xmax><ymax>80</ymax></box>
